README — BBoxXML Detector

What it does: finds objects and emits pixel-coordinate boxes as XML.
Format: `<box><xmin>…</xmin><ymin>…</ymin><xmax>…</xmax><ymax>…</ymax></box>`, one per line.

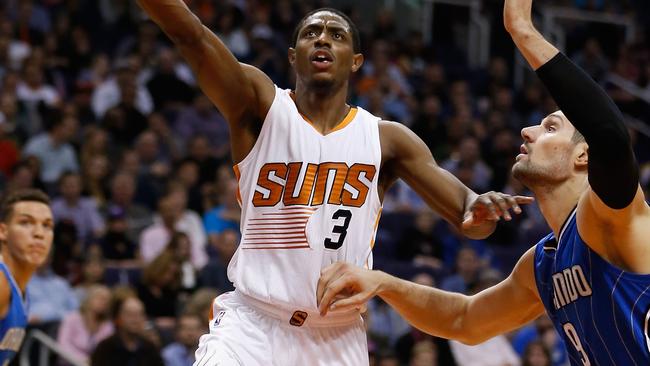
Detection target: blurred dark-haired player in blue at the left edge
<box><xmin>0</xmin><ymin>189</ymin><xmax>54</xmax><ymax>365</ymax></box>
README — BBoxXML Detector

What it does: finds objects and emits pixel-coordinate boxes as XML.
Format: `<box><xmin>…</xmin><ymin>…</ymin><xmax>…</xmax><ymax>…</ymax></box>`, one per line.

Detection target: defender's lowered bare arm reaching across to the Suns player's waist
<box><xmin>317</xmin><ymin>247</ymin><xmax>544</xmax><ymax>344</ymax></box>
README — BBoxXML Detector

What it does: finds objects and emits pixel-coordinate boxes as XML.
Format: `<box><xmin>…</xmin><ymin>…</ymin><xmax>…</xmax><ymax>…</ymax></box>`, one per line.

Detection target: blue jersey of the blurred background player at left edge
<box><xmin>0</xmin><ymin>262</ymin><xmax>27</xmax><ymax>366</ymax></box>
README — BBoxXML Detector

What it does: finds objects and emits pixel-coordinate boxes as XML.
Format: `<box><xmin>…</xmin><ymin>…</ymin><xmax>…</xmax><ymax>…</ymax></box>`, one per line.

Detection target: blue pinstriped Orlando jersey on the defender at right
<box><xmin>535</xmin><ymin>210</ymin><xmax>650</xmax><ymax>366</ymax></box>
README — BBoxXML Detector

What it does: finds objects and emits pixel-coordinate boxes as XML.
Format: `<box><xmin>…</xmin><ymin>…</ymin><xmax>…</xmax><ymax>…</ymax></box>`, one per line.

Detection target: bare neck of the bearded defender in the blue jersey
<box><xmin>533</xmin><ymin>176</ymin><xmax>589</xmax><ymax>238</ymax></box>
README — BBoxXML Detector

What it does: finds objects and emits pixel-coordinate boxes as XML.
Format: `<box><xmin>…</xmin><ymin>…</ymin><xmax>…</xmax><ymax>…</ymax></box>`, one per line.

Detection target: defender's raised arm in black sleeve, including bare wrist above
<box><xmin>504</xmin><ymin>7</ymin><xmax>639</xmax><ymax>209</ymax></box>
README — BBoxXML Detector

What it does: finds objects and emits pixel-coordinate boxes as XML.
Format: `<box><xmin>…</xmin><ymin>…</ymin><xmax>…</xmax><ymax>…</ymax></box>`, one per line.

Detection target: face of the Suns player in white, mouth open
<box><xmin>289</xmin><ymin>11</ymin><xmax>363</xmax><ymax>88</ymax></box>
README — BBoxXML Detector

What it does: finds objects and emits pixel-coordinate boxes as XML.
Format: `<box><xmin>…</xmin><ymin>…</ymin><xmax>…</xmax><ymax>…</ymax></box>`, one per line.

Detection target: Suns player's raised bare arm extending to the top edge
<box><xmin>137</xmin><ymin>0</ymin><xmax>275</xmax><ymax>162</ymax></box>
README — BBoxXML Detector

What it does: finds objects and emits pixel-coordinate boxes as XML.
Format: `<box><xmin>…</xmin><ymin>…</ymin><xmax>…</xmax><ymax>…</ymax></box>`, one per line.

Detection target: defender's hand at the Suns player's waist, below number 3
<box><xmin>316</xmin><ymin>262</ymin><xmax>381</xmax><ymax>316</ymax></box>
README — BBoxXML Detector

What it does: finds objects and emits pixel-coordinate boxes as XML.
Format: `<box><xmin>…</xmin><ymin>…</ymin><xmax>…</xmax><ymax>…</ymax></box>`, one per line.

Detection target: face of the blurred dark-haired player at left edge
<box><xmin>0</xmin><ymin>201</ymin><xmax>54</xmax><ymax>269</ymax></box>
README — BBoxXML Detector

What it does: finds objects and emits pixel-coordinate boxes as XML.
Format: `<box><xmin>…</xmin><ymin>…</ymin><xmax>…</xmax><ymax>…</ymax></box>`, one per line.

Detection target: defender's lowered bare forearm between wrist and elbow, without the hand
<box><xmin>377</xmin><ymin>272</ymin><xmax>476</xmax><ymax>343</ymax></box>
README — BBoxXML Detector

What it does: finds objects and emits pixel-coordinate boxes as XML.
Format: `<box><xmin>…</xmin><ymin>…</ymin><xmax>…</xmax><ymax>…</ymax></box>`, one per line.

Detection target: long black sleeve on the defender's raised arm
<box><xmin>536</xmin><ymin>53</ymin><xmax>639</xmax><ymax>209</ymax></box>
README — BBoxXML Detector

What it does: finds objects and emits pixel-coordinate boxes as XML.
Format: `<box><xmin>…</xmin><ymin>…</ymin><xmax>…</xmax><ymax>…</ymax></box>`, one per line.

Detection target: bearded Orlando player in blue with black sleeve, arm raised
<box><xmin>317</xmin><ymin>0</ymin><xmax>650</xmax><ymax>366</ymax></box>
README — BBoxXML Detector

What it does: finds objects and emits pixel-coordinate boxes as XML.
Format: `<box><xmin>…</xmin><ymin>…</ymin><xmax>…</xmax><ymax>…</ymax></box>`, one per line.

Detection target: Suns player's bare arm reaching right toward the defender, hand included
<box><xmin>379</xmin><ymin>121</ymin><xmax>533</xmax><ymax>239</ymax></box>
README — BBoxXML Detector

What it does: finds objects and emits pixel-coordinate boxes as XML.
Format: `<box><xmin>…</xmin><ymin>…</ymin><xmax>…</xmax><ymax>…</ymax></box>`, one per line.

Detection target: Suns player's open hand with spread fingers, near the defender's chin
<box><xmin>463</xmin><ymin>192</ymin><xmax>535</xmax><ymax>229</ymax></box>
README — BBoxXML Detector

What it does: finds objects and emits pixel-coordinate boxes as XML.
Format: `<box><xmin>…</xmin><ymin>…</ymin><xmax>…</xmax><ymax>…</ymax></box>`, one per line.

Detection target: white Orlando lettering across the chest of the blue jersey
<box><xmin>553</xmin><ymin>265</ymin><xmax>592</xmax><ymax>310</ymax></box>
